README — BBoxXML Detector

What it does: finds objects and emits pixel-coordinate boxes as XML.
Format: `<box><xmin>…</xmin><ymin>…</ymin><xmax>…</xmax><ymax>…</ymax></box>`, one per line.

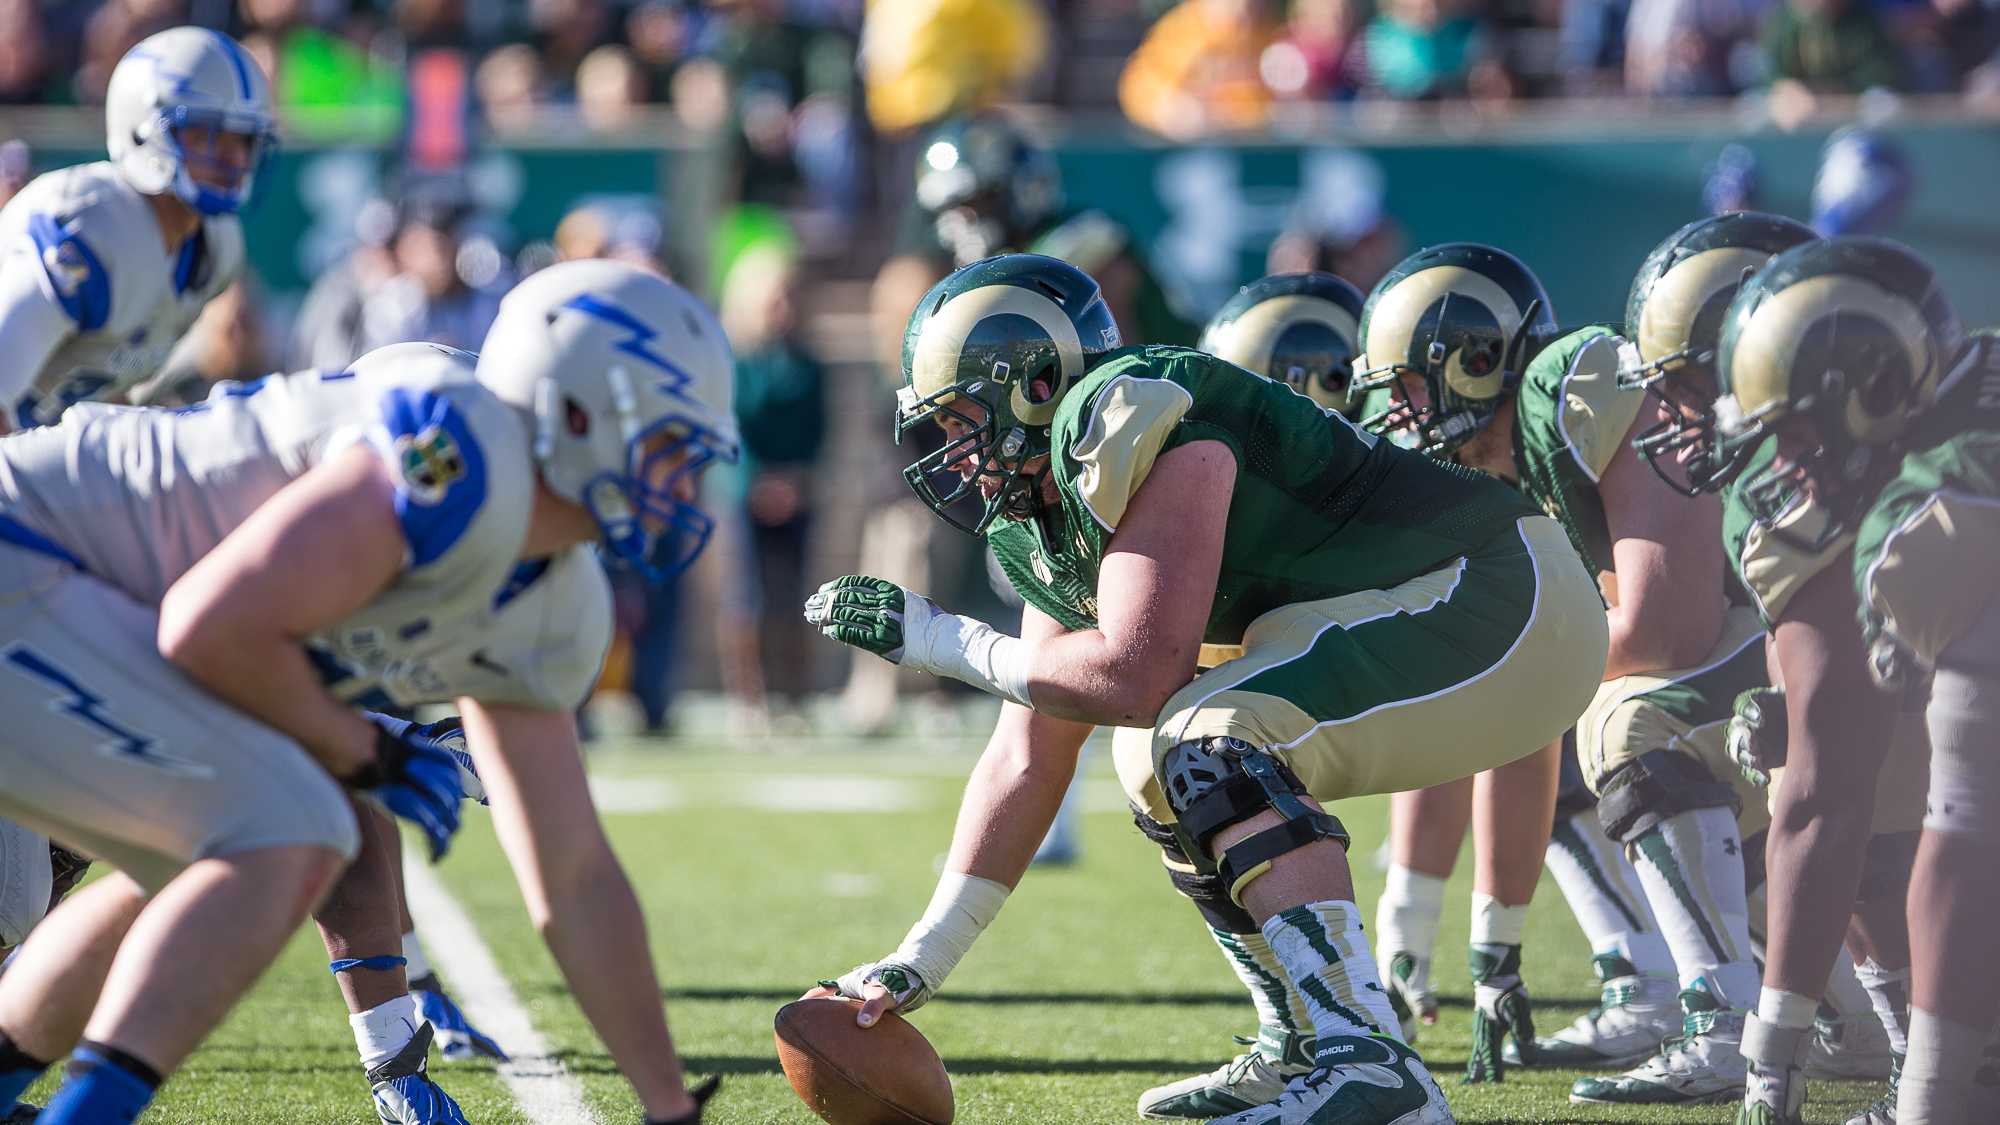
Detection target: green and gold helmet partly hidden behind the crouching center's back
<box><xmin>1196</xmin><ymin>272</ymin><xmax>1364</xmax><ymax>412</ymax></box>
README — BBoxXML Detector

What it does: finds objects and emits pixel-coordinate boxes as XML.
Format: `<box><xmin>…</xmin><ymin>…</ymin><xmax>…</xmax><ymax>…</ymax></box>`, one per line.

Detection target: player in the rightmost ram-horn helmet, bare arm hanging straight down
<box><xmin>1650</xmin><ymin>238</ymin><xmax>1960</xmax><ymax>1123</ymax></box>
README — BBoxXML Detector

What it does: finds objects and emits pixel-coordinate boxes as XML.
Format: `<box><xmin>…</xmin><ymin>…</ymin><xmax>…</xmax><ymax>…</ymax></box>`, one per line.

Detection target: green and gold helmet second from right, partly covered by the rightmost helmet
<box><xmin>1618</xmin><ymin>210</ymin><xmax>1818</xmax><ymax>496</ymax></box>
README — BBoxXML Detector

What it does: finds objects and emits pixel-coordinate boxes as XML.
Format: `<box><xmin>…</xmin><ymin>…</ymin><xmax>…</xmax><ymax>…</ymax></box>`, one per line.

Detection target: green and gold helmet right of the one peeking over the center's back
<box><xmin>1352</xmin><ymin>242</ymin><xmax>1556</xmax><ymax>456</ymax></box>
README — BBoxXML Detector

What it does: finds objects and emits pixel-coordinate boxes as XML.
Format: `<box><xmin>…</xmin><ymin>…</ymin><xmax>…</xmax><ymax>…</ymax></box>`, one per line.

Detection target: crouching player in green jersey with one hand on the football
<box><xmin>806</xmin><ymin>254</ymin><xmax>1606</xmax><ymax>1125</ymax></box>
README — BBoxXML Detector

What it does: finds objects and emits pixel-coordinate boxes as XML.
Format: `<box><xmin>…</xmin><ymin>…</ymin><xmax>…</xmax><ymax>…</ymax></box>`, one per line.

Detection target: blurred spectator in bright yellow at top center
<box><xmin>862</xmin><ymin>0</ymin><xmax>1048</xmax><ymax>132</ymax></box>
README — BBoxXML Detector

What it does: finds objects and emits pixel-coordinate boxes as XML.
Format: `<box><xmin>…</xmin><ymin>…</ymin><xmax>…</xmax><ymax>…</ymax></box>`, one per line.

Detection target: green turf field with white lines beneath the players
<box><xmin>54</xmin><ymin>739</ymin><xmax>1878</xmax><ymax>1125</ymax></box>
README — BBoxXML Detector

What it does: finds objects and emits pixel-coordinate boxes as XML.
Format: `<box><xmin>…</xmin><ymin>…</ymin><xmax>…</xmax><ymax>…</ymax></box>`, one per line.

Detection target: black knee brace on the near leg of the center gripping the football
<box><xmin>1160</xmin><ymin>737</ymin><xmax>1348</xmax><ymax>905</ymax></box>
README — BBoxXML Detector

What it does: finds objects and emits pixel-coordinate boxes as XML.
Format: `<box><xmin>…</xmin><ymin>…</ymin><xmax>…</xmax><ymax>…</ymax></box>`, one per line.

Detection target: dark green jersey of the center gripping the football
<box><xmin>986</xmin><ymin>344</ymin><xmax>1536</xmax><ymax>645</ymax></box>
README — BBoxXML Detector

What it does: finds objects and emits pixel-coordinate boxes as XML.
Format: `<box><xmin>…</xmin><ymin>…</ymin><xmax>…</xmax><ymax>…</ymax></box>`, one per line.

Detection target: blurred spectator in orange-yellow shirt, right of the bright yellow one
<box><xmin>1118</xmin><ymin>0</ymin><xmax>1278</xmax><ymax>136</ymax></box>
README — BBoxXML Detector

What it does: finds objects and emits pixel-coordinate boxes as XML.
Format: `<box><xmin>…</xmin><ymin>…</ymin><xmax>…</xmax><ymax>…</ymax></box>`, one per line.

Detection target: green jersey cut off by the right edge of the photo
<box><xmin>1854</xmin><ymin>332</ymin><xmax>2000</xmax><ymax>663</ymax></box>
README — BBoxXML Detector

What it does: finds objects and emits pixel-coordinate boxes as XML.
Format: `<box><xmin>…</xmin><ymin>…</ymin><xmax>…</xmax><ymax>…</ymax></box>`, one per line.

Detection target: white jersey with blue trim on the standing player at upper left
<box><xmin>0</xmin><ymin>162</ymin><xmax>244</xmax><ymax>428</ymax></box>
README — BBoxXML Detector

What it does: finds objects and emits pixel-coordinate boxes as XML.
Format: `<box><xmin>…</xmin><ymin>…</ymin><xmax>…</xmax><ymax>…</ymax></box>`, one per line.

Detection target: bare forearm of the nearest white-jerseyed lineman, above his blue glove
<box><xmin>158</xmin><ymin>608</ymin><xmax>376</xmax><ymax>777</ymax></box>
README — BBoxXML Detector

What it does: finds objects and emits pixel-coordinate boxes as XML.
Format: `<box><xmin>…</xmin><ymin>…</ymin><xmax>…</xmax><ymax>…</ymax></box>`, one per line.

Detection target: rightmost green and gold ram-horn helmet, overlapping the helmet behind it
<box><xmin>1710</xmin><ymin>238</ymin><xmax>1972</xmax><ymax>542</ymax></box>
